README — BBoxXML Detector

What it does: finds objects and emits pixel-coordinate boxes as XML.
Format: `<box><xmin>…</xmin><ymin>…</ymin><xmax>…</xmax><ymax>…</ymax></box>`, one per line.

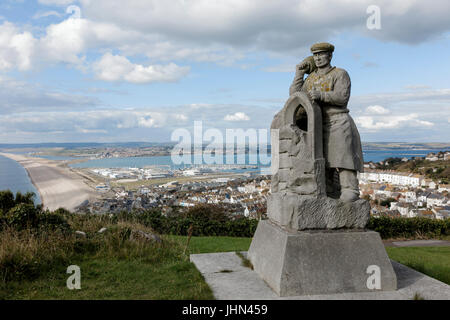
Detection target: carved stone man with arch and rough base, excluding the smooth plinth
<box><xmin>267</xmin><ymin>43</ymin><xmax>370</xmax><ymax>230</ymax></box>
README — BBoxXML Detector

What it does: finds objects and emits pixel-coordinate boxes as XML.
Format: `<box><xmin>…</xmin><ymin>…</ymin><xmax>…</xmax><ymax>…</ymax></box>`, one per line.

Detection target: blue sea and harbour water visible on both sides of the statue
<box><xmin>0</xmin><ymin>149</ymin><xmax>441</xmax><ymax>203</ymax></box>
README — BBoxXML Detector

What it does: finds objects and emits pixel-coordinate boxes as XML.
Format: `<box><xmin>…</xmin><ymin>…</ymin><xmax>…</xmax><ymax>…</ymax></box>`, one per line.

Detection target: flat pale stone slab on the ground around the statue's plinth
<box><xmin>190</xmin><ymin>251</ymin><xmax>450</xmax><ymax>303</ymax></box>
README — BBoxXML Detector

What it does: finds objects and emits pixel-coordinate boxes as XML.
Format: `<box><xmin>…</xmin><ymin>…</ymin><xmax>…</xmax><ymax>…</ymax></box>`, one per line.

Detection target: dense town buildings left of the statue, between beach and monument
<box><xmin>76</xmin><ymin>168</ymin><xmax>270</xmax><ymax>219</ymax></box>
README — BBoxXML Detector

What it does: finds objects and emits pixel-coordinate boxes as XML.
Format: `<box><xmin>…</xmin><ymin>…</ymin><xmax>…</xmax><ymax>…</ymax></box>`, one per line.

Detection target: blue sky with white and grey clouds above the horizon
<box><xmin>0</xmin><ymin>0</ymin><xmax>450</xmax><ymax>143</ymax></box>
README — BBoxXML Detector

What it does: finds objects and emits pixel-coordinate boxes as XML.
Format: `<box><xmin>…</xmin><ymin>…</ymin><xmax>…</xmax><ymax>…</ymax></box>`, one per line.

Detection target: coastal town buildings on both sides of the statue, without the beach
<box><xmin>68</xmin><ymin>151</ymin><xmax>450</xmax><ymax>219</ymax></box>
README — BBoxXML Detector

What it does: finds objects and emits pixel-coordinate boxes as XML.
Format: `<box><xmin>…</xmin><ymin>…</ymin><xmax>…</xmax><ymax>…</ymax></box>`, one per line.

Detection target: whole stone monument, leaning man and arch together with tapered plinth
<box><xmin>248</xmin><ymin>43</ymin><xmax>397</xmax><ymax>296</ymax></box>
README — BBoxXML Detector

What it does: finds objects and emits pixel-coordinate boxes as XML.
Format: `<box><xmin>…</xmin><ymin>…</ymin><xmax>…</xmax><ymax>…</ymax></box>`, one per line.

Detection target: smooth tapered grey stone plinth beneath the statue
<box><xmin>248</xmin><ymin>220</ymin><xmax>397</xmax><ymax>297</ymax></box>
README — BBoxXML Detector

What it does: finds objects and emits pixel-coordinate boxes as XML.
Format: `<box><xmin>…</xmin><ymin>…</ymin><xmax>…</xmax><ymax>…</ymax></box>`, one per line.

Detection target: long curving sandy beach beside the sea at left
<box><xmin>0</xmin><ymin>153</ymin><xmax>96</xmax><ymax>211</ymax></box>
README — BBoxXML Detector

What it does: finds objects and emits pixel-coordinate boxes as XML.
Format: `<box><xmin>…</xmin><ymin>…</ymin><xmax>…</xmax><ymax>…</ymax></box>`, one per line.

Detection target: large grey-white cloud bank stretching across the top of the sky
<box><xmin>0</xmin><ymin>0</ymin><xmax>450</xmax><ymax>76</ymax></box>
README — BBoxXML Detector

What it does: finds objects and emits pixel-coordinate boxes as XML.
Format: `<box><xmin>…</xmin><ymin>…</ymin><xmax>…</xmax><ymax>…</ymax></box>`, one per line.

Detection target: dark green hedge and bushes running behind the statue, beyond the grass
<box><xmin>0</xmin><ymin>192</ymin><xmax>450</xmax><ymax>239</ymax></box>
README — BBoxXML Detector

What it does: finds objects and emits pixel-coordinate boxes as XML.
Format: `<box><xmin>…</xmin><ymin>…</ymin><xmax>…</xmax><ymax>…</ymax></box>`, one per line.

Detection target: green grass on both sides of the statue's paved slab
<box><xmin>0</xmin><ymin>231</ymin><xmax>450</xmax><ymax>300</ymax></box>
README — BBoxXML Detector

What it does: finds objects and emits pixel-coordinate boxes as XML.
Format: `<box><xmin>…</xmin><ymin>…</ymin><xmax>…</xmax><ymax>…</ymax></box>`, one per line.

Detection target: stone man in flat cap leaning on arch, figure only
<box><xmin>289</xmin><ymin>43</ymin><xmax>363</xmax><ymax>202</ymax></box>
